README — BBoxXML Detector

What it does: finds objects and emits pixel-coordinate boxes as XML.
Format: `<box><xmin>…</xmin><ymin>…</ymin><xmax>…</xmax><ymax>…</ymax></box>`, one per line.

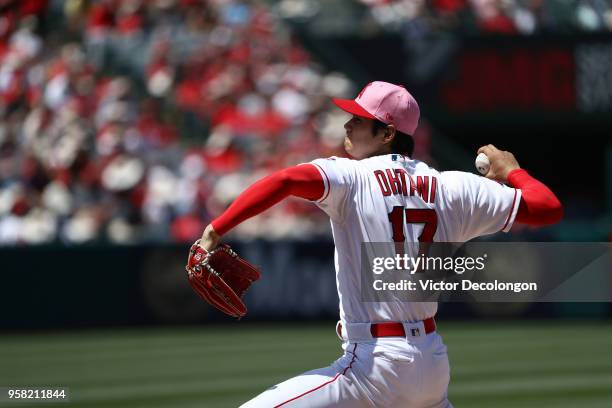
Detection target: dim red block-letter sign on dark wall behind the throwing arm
<box><xmin>440</xmin><ymin>48</ymin><xmax>576</xmax><ymax>113</ymax></box>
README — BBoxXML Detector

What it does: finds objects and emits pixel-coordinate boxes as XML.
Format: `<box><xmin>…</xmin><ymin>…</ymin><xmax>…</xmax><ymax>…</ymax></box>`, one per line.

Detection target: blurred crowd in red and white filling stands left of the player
<box><xmin>0</xmin><ymin>0</ymin><xmax>353</xmax><ymax>244</ymax></box>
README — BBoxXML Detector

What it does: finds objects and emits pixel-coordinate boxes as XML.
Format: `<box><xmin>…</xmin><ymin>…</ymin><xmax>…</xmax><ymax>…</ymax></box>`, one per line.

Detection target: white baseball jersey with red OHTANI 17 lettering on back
<box><xmin>311</xmin><ymin>154</ymin><xmax>521</xmax><ymax>323</ymax></box>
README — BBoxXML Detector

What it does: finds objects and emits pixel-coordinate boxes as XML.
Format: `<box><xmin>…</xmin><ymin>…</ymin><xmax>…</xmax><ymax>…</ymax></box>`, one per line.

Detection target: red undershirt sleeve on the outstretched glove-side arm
<box><xmin>211</xmin><ymin>164</ymin><xmax>325</xmax><ymax>235</ymax></box>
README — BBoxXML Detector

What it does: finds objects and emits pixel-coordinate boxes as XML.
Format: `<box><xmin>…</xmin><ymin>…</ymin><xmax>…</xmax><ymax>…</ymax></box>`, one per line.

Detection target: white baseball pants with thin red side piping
<box><xmin>241</xmin><ymin>324</ymin><xmax>452</xmax><ymax>408</ymax></box>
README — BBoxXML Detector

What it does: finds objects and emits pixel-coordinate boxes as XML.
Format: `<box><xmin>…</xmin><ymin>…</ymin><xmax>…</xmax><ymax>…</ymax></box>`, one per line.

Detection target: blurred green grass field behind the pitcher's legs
<box><xmin>0</xmin><ymin>322</ymin><xmax>612</xmax><ymax>408</ymax></box>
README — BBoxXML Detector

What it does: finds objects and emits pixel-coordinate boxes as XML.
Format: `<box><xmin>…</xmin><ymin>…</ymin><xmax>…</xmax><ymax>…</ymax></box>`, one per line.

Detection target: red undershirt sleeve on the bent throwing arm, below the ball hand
<box><xmin>508</xmin><ymin>169</ymin><xmax>563</xmax><ymax>226</ymax></box>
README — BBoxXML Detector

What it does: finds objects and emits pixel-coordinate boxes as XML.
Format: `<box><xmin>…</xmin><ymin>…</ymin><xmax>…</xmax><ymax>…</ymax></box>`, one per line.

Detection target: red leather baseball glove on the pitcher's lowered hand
<box><xmin>185</xmin><ymin>240</ymin><xmax>261</xmax><ymax>318</ymax></box>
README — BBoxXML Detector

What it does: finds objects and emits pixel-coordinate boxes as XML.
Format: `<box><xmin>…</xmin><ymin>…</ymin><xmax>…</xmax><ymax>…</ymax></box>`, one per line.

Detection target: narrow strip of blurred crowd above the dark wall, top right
<box><xmin>360</xmin><ymin>0</ymin><xmax>612</xmax><ymax>37</ymax></box>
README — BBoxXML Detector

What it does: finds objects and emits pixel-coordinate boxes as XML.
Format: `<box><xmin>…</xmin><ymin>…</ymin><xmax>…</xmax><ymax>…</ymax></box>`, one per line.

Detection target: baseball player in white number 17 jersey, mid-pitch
<box><xmin>200</xmin><ymin>82</ymin><xmax>563</xmax><ymax>408</ymax></box>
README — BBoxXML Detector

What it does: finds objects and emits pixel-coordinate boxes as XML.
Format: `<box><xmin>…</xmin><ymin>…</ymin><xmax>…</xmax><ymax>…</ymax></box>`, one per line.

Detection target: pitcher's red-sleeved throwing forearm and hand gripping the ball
<box><xmin>478</xmin><ymin>145</ymin><xmax>563</xmax><ymax>226</ymax></box>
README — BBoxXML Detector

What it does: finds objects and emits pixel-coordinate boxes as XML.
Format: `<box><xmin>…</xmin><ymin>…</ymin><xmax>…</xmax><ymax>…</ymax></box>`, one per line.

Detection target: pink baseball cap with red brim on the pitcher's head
<box><xmin>332</xmin><ymin>81</ymin><xmax>420</xmax><ymax>136</ymax></box>
